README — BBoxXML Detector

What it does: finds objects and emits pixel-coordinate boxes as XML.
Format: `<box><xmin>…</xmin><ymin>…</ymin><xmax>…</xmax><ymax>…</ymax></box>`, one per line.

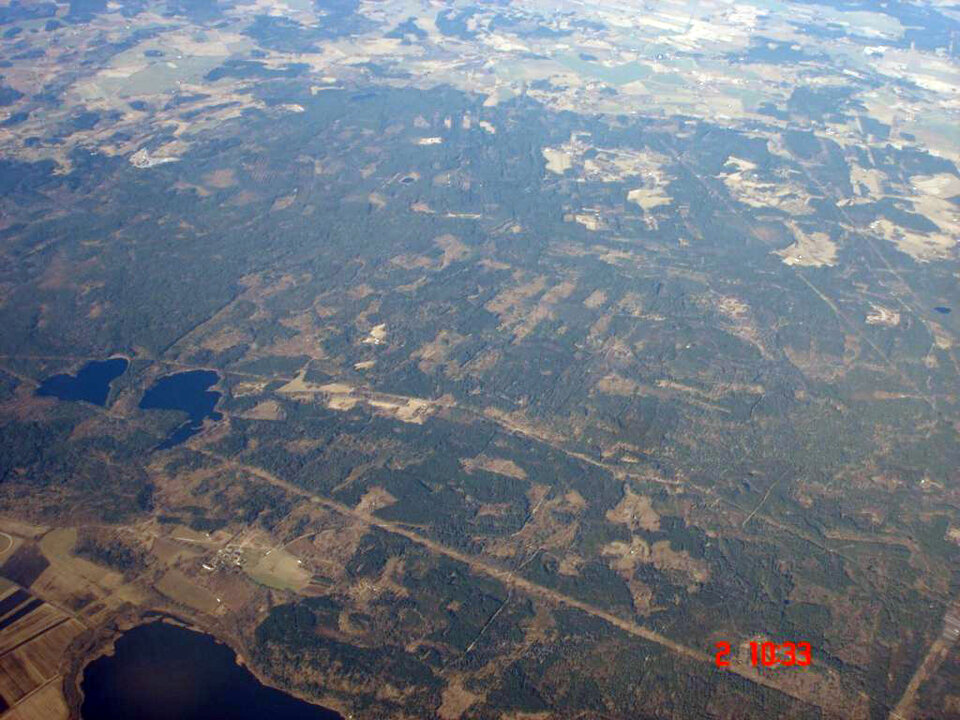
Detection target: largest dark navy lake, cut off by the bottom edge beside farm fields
<box><xmin>80</xmin><ymin>622</ymin><xmax>343</xmax><ymax>720</ymax></box>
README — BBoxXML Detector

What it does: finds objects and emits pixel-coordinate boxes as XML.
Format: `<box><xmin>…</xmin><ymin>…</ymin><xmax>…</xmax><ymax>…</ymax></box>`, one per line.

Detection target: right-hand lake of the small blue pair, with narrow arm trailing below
<box><xmin>140</xmin><ymin>370</ymin><xmax>223</xmax><ymax>450</ymax></box>
